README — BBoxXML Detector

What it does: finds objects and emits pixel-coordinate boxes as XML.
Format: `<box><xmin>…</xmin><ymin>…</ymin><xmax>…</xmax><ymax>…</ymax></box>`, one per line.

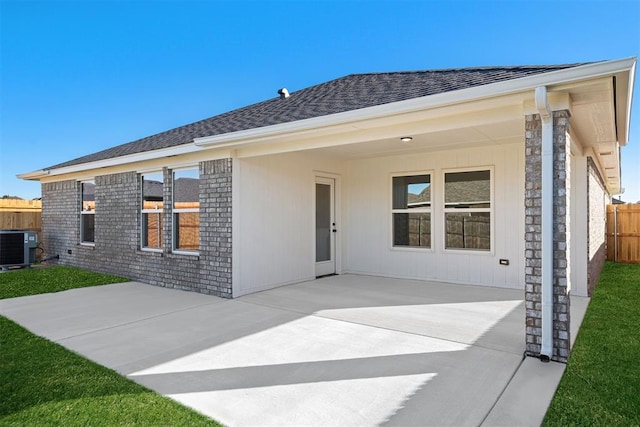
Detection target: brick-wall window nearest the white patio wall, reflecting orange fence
<box><xmin>173</xmin><ymin>169</ymin><xmax>200</xmax><ymax>252</ymax></box>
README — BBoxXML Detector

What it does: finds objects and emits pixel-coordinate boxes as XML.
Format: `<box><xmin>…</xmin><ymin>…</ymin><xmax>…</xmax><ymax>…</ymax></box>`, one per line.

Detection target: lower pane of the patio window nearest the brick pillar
<box><xmin>445</xmin><ymin>212</ymin><xmax>491</xmax><ymax>251</ymax></box>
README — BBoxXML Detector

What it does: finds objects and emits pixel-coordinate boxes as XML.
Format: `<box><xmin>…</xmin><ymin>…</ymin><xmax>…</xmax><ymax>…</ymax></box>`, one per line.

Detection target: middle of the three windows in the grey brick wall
<box><xmin>140</xmin><ymin>172</ymin><xmax>164</xmax><ymax>249</ymax></box>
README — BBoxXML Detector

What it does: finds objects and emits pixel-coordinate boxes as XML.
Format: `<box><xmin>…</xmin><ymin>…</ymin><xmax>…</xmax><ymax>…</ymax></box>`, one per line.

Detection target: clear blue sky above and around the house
<box><xmin>0</xmin><ymin>0</ymin><xmax>640</xmax><ymax>201</ymax></box>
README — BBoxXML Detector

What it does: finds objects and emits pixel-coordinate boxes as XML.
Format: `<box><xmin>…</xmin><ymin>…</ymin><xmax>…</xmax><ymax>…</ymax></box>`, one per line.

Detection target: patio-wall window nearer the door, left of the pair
<box><xmin>392</xmin><ymin>175</ymin><xmax>431</xmax><ymax>248</ymax></box>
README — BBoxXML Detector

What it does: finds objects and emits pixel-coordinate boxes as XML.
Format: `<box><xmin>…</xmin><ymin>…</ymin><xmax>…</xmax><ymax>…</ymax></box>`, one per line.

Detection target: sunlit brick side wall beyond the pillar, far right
<box><xmin>587</xmin><ymin>157</ymin><xmax>607</xmax><ymax>296</ymax></box>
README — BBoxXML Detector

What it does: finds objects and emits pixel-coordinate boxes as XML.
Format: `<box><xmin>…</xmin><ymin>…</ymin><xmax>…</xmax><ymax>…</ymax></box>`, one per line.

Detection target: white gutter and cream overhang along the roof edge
<box><xmin>18</xmin><ymin>58</ymin><xmax>636</xmax><ymax>194</ymax></box>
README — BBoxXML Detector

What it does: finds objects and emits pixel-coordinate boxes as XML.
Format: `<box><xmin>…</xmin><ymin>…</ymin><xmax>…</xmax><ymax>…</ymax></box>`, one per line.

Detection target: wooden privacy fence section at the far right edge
<box><xmin>607</xmin><ymin>204</ymin><xmax>640</xmax><ymax>263</ymax></box>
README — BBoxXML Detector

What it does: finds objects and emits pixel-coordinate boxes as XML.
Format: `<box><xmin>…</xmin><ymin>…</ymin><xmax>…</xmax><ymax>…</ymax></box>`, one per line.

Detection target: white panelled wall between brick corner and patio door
<box><xmin>233</xmin><ymin>152</ymin><xmax>342</xmax><ymax>296</ymax></box>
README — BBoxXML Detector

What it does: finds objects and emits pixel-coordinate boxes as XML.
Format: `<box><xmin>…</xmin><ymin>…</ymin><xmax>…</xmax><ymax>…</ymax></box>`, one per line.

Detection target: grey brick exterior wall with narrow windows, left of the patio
<box><xmin>42</xmin><ymin>159</ymin><xmax>232</xmax><ymax>298</ymax></box>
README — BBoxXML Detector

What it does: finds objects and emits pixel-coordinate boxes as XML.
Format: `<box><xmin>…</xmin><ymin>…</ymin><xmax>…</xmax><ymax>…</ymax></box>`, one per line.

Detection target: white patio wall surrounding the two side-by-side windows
<box><xmin>343</xmin><ymin>142</ymin><xmax>525</xmax><ymax>288</ymax></box>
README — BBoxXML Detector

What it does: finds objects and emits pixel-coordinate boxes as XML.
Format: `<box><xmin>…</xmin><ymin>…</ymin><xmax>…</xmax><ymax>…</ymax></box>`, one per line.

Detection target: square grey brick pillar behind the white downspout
<box><xmin>525</xmin><ymin>110</ymin><xmax>571</xmax><ymax>363</ymax></box>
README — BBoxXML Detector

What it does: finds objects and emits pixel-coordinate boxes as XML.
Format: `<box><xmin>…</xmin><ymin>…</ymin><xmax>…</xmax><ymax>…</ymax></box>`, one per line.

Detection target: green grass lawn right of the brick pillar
<box><xmin>544</xmin><ymin>263</ymin><xmax>640</xmax><ymax>426</ymax></box>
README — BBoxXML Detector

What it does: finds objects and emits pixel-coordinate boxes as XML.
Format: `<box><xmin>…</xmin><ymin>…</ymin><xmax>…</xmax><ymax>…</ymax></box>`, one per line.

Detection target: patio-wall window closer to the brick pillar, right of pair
<box><xmin>444</xmin><ymin>170</ymin><xmax>492</xmax><ymax>251</ymax></box>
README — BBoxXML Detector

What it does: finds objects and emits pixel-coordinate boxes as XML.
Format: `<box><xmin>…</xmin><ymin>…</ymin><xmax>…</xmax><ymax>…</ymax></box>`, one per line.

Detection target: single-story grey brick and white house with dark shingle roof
<box><xmin>20</xmin><ymin>58</ymin><xmax>636</xmax><ymax>361</ymax></box>
